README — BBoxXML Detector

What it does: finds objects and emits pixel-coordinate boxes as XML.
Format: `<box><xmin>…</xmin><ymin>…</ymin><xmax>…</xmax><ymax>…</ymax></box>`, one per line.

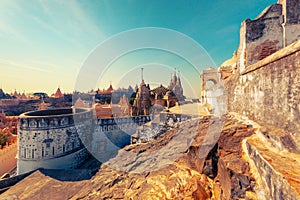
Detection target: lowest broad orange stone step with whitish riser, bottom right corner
<box><xmin>243</xmin><ymin>133</ymin><xmax>300</xmax><ymax>200</ymax></box>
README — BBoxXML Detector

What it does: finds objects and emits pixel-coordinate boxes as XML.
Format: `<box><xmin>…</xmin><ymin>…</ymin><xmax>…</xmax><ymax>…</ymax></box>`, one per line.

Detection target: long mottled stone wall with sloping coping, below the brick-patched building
<box><xmin>225</xmin><ymin>41</ymin><xmax>300</xmax><ymax>144</ymax></box>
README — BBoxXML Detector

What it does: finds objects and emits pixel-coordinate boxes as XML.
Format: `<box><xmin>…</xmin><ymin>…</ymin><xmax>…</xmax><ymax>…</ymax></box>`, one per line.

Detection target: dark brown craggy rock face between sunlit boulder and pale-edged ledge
<box><xmin>215</xmin><ymin>119</ymin><xmax>255</xmax><ymax>199</ymax></box>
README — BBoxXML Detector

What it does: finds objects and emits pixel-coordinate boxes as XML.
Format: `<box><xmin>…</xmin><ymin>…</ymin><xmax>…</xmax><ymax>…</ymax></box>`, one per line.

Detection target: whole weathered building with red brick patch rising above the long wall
<box><xmin>237</xmin><ymin>0</ymin><xmax>300</xmax><ymax>72</ymax></box>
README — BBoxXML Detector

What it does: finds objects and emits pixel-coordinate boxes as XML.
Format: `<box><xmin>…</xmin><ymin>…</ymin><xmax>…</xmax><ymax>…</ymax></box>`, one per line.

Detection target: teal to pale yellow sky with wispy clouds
<box><xmin>0</xmin><ymin>0</ymin><xmax>276</xmax><ymax>96</ymax></box>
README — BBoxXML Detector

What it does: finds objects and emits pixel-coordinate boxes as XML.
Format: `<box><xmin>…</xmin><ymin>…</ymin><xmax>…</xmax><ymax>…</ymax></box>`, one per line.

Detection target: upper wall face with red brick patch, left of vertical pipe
<box><xmin>238</xmin><ymin>4</ymin><xmax>283</xmax><ymax>70</ymax></box>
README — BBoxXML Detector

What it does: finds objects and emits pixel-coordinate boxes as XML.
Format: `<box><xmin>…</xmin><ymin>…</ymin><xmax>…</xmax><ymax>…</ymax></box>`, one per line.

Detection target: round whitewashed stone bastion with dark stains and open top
<box><xmin>17</xmin><ymin>108</ymin><xmax>92</xmax><ymax>174</ymax></box>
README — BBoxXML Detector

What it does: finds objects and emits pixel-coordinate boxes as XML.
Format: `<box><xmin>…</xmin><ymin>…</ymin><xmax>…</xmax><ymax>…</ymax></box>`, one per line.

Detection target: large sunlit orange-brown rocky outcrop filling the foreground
<box><xmin>0</xmin><ymin>115</ymin><xmax>262</xmax><ymax>199</ymax></box>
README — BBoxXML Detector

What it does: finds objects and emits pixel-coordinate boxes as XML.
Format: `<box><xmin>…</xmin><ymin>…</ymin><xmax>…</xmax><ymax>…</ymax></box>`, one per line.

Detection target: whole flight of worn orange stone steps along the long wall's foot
<box><xmin>233</xmin><ymin>113</ymin><xmax>300</xmax><ymax>200</ymax></box>
